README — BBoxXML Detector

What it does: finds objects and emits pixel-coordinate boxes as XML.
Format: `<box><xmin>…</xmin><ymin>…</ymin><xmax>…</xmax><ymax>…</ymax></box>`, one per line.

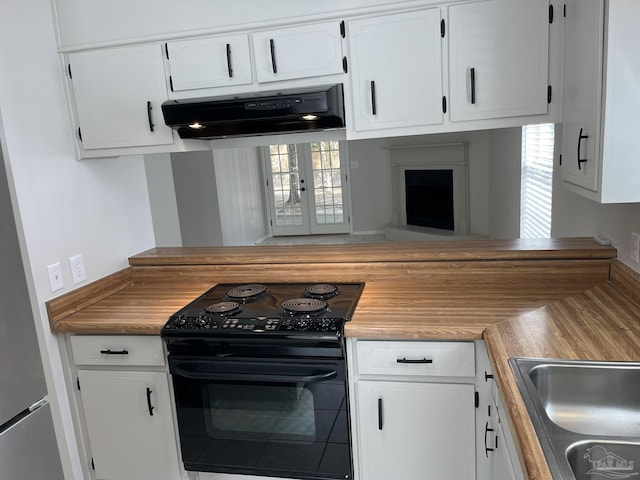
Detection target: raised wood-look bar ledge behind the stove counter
<box><xmin>129</xmin><ymin>238</ymin><xmax>617</xmax><ymax>266</ymax></box>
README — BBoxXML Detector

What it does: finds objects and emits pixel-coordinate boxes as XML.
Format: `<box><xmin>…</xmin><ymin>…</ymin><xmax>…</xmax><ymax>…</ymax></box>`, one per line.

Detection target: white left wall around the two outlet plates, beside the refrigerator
<box><xmin>0</xmin><ymin>0</ymin><xmax>154</xmax><ymax>479</ymax></box>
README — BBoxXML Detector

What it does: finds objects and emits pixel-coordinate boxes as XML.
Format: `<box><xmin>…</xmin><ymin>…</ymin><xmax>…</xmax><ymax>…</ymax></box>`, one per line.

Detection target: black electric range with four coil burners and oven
<box><xmin>161</xmin><ymin>283</ymin><xmax>364</xmax><ymax>480</ymax></box>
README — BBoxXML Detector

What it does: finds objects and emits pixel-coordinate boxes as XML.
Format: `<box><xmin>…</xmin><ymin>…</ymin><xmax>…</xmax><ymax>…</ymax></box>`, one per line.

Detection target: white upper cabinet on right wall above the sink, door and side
<box><xmin>561</xmin><ymin>0</ymin><xmax>640</xmax><ymax>203</ymax></box>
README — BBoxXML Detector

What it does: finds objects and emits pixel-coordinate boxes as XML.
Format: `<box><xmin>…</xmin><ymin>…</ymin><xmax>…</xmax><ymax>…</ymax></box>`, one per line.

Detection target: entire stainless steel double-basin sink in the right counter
<box><xmin>509</xmin><ymin>357</ymin><xmax>640</xmax><ymax>480</ymax></box>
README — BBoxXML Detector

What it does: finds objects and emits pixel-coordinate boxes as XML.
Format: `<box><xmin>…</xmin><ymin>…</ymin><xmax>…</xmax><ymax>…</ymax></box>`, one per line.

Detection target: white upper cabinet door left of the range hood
<box><xmin>69</xmin><ymin>44</ymin><xmax>173</xmax><ymax>150</ymax></box>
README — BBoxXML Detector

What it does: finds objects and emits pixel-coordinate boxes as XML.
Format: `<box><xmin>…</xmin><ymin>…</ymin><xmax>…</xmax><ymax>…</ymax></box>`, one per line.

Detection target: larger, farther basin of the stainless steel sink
<box><xmin>528</xmin><ymin>362</ymin><xmax>640</xmax><ymax>437</ymax></box>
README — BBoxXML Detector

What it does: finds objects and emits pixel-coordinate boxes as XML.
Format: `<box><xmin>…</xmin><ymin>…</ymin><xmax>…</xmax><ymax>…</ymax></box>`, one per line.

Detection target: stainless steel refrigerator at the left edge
<box><xmin>0</xmin><ymin>141</ymin><xmax>64</xmax><ymax>480</ymax></box>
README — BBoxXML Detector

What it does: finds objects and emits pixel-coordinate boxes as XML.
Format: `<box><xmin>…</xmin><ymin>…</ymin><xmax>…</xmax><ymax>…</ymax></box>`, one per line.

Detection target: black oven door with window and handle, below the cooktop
<box><xmin>169</xmin><ymin>355</ymin><xmax>352</xmax><ymax>479</ymax></box>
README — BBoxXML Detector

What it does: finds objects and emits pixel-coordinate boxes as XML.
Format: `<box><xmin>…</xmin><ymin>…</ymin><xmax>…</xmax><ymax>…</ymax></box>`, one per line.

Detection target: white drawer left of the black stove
<box><xmin>70</xmin><ymin>335</ymin><xmax>165</xmax><ymax>366</ymax></box>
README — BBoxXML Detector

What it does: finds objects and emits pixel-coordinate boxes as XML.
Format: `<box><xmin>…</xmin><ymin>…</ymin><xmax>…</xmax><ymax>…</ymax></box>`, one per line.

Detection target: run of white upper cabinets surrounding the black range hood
<box><xmin>60</xmin><ymin>0</ymin><xmax>556</xmax><ymax>154</ymax></box>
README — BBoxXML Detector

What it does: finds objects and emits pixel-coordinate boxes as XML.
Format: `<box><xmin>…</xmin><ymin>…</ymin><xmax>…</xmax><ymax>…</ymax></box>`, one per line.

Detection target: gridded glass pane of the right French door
<box><xmin>311</xmin><ymin>141</ymin><xmax>344</xmax><ymax>224</ymax></box>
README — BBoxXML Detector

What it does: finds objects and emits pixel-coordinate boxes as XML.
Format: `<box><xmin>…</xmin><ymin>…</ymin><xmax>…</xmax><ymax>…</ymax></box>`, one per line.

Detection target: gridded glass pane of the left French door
<box><xmin>269</xmin><ymin>145</ymin><xmax>303</xmax><ymax>227</ymax></box>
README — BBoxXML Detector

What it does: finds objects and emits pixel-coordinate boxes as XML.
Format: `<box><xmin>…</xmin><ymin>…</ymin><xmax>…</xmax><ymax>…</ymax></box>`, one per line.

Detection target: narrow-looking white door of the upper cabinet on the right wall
<box><xmin>562</xmin><ymin>0</ymin><xmax>604</xmax><ymax>191</ymax></box>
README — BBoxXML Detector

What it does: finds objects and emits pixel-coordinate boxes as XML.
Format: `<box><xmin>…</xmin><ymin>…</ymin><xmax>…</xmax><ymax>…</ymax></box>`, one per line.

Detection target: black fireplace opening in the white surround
<box><xmin>405</xmin><ymin>170</ymin><xmax>455</xmax><ymax>231</ymax></box>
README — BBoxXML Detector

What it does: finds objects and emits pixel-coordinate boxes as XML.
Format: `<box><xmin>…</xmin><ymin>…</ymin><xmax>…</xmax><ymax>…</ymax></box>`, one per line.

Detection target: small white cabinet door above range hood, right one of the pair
<box><xmin>251</xmin><ymin>22</ymin><xmax>343</xmax><ymax>82</ymax></box>
